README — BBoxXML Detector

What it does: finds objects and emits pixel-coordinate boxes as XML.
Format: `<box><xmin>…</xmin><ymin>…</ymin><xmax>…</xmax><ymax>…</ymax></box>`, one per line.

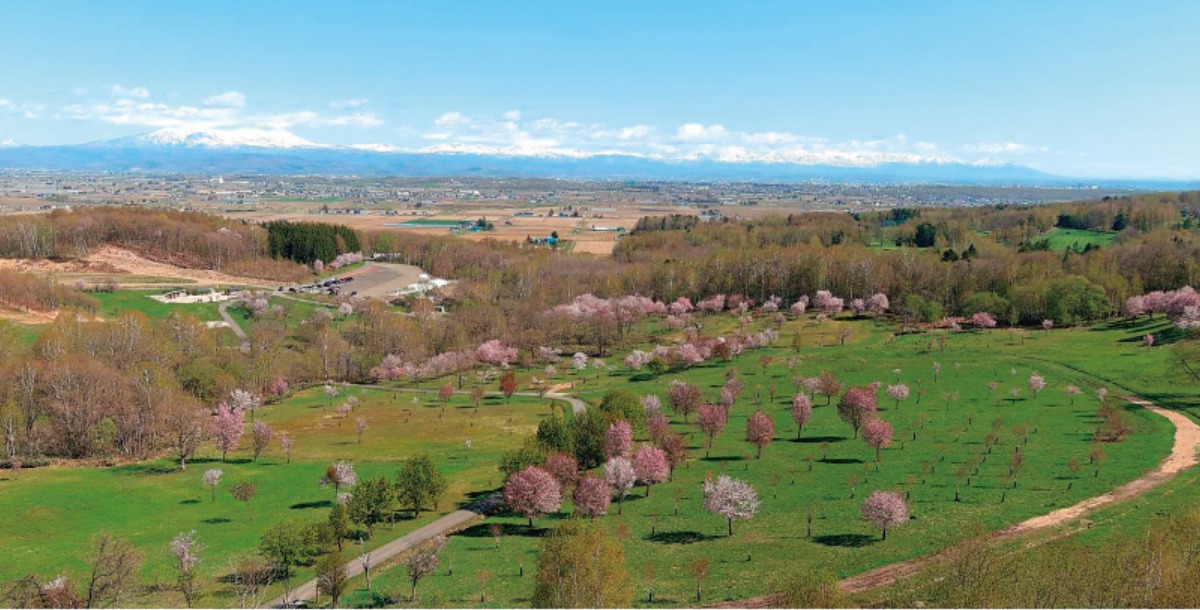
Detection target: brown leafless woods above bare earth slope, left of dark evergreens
<box><xmin>0</xmin><ymin>207</ymin><xmax>306</xmax><ymax>281</ymax></box>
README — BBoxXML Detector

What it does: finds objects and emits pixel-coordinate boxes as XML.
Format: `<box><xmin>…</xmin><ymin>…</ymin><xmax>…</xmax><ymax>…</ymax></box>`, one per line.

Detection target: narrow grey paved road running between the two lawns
<box><xmin>266</xmin><ymin>381</ymin><xmax>588</xmax><ymax>608</ymax></box>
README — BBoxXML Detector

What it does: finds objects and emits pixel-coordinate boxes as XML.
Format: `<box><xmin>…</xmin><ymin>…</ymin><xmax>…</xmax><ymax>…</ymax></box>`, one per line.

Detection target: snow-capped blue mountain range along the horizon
<box><xmin>0</xmin><ymin>128</ymin><xmax>1066</xmax><ymax>184</ymax></box>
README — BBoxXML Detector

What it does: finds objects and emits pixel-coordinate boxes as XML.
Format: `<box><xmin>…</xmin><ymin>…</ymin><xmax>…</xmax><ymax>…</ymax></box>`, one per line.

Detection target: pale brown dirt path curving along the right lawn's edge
<box><xmin>716</xmin><ymin>396</ymin><xmax>1200</xmax><ymax>608</ymax></box>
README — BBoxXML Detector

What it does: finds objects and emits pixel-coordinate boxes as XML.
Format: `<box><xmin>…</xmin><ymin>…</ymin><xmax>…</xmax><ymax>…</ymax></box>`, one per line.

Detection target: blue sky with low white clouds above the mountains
<box><xmin>0</xmin><ymin>0</ymin><xmax>1200</xmax><ymax>179</ymax></box>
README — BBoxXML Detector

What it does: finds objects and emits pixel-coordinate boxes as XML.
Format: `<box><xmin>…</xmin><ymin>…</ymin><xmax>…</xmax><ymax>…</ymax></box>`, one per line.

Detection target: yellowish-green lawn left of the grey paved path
<box><xmin>0</xmin><ymin>388</ymin><xmax>550</xmax><ymax>606</ymax></box>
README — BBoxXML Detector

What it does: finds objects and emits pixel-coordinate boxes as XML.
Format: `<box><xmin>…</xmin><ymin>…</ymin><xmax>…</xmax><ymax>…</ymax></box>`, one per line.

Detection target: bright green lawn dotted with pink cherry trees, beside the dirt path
<box><xmin>352</xmin><ymin>319</ymin><xmax>1172</xmax><ymax>606</ymax></box>
